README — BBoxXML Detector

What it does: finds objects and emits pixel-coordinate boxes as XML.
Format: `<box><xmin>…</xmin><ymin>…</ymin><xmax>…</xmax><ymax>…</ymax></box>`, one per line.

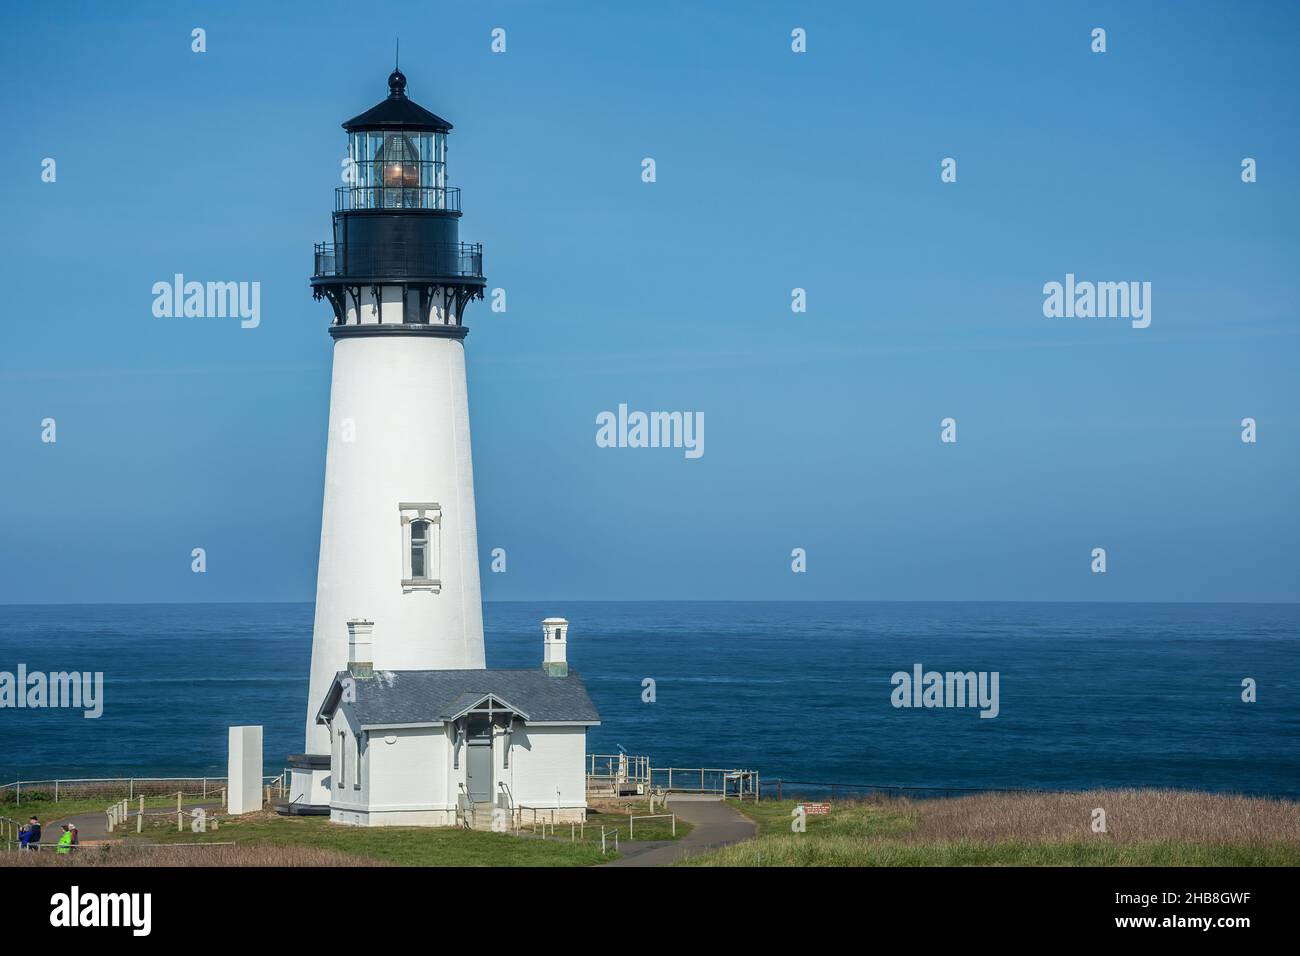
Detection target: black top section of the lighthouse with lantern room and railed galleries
<box><xmin>312</xmin><ymin>70</ymin><xmax>485</xmax><ymax>338</ymax></box>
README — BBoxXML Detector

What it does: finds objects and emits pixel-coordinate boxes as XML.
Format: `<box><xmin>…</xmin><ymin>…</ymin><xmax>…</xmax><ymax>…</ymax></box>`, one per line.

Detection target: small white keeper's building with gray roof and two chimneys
<box><xmin>316</xmin><ymin>618</ymin><xmax>599</xmax><ymax>827</ymax></box>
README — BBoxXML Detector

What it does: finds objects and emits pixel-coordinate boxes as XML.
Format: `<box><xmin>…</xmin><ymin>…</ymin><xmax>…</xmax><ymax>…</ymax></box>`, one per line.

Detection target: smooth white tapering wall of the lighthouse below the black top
<box><xmin>306</xmin><ymin>336</ymin><xmax>484</xmax><ymax>754</ymax></box>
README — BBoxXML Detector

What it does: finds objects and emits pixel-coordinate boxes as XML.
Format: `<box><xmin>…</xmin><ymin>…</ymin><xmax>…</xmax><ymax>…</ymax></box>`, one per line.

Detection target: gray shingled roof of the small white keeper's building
<box><xmin>321</xmin><ymin>667</ymin><xmax>601</xmax><ymax>727</ymax></box>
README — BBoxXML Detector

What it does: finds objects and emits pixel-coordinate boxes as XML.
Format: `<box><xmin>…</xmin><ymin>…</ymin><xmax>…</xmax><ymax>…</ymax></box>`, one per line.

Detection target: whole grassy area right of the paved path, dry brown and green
<box><xmin>685</xmin><ymin>790</ymin><xmax>1300</xmax><ymax>866</ymax></box>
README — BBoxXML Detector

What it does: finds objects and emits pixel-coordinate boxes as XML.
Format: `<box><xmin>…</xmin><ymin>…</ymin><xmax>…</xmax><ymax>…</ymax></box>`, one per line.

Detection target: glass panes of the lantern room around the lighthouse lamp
<box><xmin>348</xmin><ymin>130</ymin><xmax>447</xmax><ymax>209</ymax></box>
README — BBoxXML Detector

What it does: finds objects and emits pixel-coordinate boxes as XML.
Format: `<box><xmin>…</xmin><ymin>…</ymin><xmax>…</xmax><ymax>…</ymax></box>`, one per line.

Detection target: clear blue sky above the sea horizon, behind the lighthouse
<box><xmin>0</xmin><ymin>1</ymin><xmax>1300</xmax><ymax>602</ymax></box>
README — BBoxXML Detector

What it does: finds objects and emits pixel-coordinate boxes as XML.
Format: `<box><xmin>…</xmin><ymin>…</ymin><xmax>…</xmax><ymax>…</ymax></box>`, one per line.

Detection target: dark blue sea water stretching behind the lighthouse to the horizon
<box><xmin>0</xmin><ymin>602</ymin><xmax>1300</xmax><ymax>797</ymax></box>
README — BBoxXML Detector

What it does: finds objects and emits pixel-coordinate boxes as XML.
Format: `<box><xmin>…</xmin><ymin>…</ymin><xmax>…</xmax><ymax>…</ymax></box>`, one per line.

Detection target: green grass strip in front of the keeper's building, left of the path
<box><xmin>130</xmin><ymin>816</ymin><xmax>615</xmax><ymax>866</ymax></box>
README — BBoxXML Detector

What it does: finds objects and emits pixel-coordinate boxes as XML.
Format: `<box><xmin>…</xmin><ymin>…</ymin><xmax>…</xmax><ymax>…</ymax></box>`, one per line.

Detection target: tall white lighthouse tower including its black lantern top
<box><xmin>290</xmin><ymin>70</ymin><xmax>485</xmax><ymax>812</ymax></box>
